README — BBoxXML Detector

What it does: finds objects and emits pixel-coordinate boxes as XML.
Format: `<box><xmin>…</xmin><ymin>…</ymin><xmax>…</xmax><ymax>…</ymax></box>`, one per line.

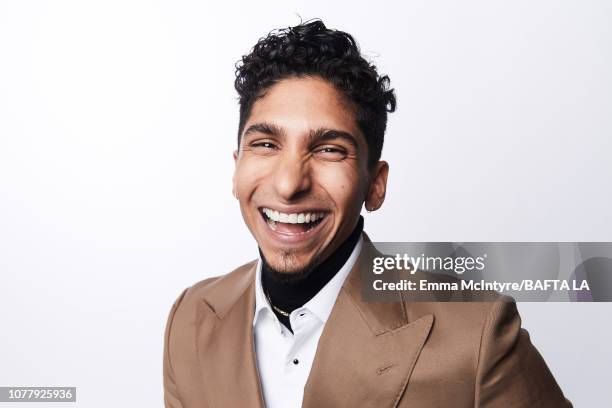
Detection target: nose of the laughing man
<box><xmin>274</xmin><ymin>150</ymin><xmax>312</xmax><ymax>202</ymax></box>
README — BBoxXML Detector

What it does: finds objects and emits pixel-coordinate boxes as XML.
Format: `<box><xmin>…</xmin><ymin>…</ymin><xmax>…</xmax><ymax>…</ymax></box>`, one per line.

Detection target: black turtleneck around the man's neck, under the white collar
<box><xmin>259</xmin><ymin>216</ymin><xmax>363</xmax><ymax>331</ymax></box>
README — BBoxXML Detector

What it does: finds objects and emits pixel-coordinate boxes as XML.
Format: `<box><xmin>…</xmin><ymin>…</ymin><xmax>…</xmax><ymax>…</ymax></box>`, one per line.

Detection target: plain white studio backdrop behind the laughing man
<box><xmin>0</xmin><ymin>0</ymin><xmax>612</xmax><ymax>407</ymax></box>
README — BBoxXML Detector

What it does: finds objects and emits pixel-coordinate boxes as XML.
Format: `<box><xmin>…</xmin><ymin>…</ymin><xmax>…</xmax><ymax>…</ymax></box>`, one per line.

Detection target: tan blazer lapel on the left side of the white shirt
<box><xmin>196</xmin><ymin>263</ymin><xmax>263</xmax><ymax>408</ymax></box>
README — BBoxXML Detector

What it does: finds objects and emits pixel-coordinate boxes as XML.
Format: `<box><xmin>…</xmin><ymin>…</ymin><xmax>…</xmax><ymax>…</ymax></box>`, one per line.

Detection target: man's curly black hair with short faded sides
<box><xmin>234</xmin><ymin>19</ymin><xmax>396</xmax><ymax>166</ymax></box>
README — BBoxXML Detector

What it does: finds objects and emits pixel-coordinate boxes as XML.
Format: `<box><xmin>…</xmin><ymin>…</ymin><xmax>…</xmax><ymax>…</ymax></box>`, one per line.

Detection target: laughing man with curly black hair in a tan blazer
<box><xmin>164</xmin><ymin>21</ymin><xmax>571</xmax><ymax>408</ymax></box>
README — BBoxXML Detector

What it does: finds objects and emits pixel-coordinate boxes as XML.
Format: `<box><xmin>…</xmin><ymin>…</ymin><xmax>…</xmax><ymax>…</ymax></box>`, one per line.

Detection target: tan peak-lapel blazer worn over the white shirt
<box><xmin>164</xmin><ymin>234</ymin><xmax>571</xmax><ymax>408</ymax></box>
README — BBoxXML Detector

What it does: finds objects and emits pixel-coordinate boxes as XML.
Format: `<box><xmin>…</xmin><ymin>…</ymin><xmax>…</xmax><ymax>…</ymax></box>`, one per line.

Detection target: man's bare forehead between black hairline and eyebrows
<box><xmin>245</xmin><ymin>77</ymin><xmax>363</xmax><ymax>137</ymax></box>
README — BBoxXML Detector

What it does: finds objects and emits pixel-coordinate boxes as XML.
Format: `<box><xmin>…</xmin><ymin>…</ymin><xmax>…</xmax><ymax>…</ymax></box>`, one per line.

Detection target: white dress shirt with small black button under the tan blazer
<box><xmin>253</xmin><ymin>237</ymin><xmax>363</xmax><ymax>408</ymax></box>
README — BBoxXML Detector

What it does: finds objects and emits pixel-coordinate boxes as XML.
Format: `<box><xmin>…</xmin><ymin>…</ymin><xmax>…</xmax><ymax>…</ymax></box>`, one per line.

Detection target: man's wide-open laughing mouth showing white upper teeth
<box><xmin>259</xmin><ymin>207</ymin><xmax>328</xmax><ymax>238</ymax></box>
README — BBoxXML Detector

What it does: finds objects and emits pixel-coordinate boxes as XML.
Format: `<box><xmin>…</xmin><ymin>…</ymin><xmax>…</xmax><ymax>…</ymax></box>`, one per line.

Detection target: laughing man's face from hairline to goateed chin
<box><xmin>234</xmin><ymin>78</ymin><xmax>386</xmax><ymax>273</ymax></box>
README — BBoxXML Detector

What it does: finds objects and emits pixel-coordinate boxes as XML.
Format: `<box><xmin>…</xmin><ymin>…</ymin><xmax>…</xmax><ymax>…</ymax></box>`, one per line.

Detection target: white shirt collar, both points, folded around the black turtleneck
<box><xmin>253</xmin><ymin>234</ymin><xmax>363</xmax><ymax>326</ymax></box>
